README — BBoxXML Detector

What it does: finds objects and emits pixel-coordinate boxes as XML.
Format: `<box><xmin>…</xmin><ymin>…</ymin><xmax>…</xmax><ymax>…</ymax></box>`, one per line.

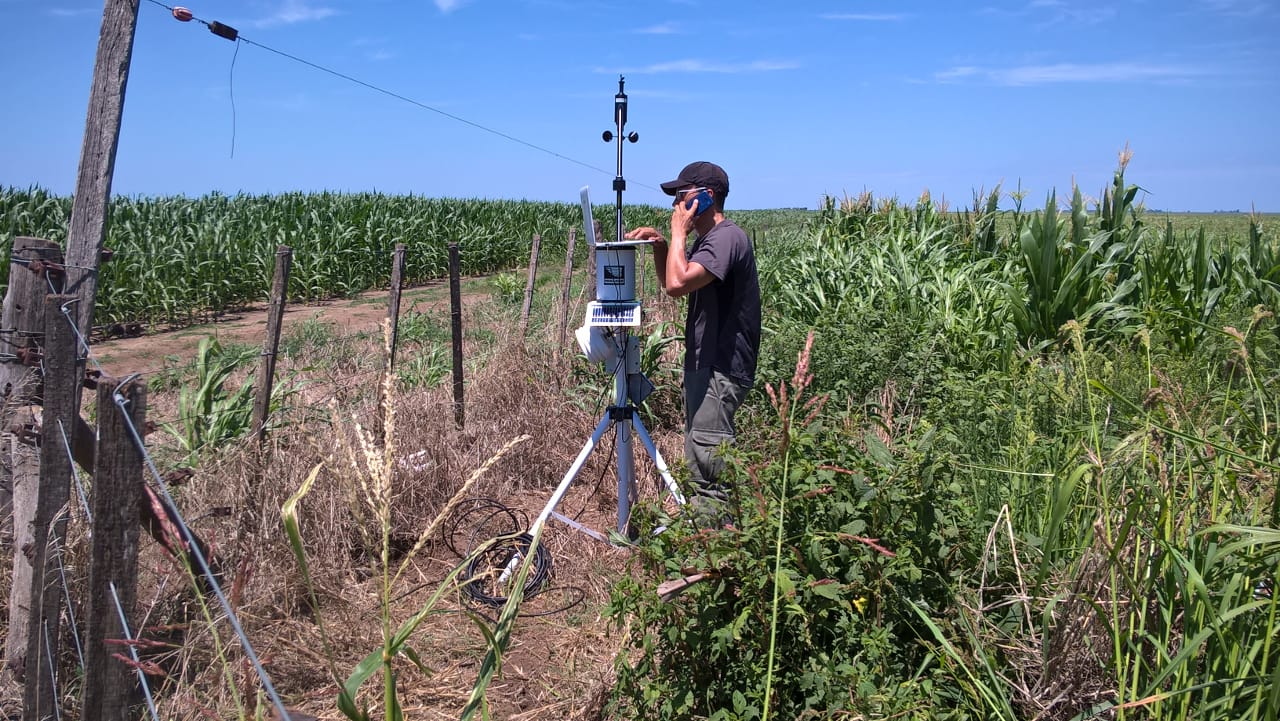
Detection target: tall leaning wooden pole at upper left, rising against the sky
<box><xmin>67</xmin><ymin>0</ymin><xmax>140</xmax><ymax>338</ymax></box>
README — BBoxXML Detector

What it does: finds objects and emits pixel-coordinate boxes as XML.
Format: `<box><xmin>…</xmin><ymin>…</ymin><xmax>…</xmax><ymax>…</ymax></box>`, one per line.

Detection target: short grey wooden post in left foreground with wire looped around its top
<box><xmin>81</xmin><ymin>378</ymin><xmax>147</xmax><ymax>721</ymax></box>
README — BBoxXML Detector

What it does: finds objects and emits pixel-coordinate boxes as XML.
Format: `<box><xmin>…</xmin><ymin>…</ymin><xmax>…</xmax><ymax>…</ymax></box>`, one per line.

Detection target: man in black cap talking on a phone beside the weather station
<box><xmin>626</xmin><ymin>161</ymin><xmax>760</xmax><ymax>523</ymax></box>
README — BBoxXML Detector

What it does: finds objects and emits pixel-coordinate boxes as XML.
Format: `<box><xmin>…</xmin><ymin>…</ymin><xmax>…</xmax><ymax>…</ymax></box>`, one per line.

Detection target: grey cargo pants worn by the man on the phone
<box><xmin>685</xmin><ymin>368</ymin><xmax>750</xmax><ymax>525</ymax></box>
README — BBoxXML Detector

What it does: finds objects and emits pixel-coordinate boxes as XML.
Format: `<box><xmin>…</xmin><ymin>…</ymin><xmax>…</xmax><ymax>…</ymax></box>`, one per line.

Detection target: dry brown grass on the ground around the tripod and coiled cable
<box><xmin>97</xmin><ymin>320</ymin><xmax>681</xmax><ymax>720</ymax></box>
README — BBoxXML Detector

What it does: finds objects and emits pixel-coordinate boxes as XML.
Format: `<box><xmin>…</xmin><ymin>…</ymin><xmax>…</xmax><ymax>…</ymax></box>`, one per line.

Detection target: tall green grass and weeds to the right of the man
<box><xmin>614</xmin><ymin>156</ymin><xmax>1280</xmax><ymax>721</ymax></box>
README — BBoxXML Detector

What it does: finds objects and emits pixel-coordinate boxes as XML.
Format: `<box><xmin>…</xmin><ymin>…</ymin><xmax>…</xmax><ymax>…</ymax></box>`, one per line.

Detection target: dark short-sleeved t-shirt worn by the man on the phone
<box><xmin>685</xmin><ymin>220</ymin><xmax>760</xmax><ymax>385</ymax></box>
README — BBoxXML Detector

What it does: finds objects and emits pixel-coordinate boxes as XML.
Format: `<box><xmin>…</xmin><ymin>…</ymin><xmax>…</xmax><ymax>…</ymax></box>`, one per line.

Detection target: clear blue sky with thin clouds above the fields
<box><xmin>0</xmin><ymin>0</ymin><xmax>1280</xmax><ymax>211</ymax></box>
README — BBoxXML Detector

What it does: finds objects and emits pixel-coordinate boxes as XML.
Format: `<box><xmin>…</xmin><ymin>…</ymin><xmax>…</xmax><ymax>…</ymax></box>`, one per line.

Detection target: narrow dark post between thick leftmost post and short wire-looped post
<box><xmin>22</xmin><ymin>296</ymin><xmax>79</xmax><ymax>721</ymax></box>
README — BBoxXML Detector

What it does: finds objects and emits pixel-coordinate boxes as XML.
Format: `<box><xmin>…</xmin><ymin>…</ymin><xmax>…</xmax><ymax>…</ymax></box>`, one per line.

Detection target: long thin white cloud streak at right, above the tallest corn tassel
<box><xmin>933</xmin><ymin>63</ymin><xmax>1207</xmax><ymax>86</ymax></box>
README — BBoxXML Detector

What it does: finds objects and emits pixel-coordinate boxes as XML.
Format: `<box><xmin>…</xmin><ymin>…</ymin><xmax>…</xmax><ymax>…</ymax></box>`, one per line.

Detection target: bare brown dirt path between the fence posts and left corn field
<box><xmin>93</xmin><ymin>279</ymin><xmax>471</xmax><ymax>377</ymax></box>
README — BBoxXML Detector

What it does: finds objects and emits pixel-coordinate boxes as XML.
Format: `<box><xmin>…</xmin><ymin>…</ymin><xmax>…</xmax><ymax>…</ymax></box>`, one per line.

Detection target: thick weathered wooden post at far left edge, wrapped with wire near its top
<box><xmin>0</xmin><ymin>237</ymin><xmax>63</xmax><ymax>679</ymax></box>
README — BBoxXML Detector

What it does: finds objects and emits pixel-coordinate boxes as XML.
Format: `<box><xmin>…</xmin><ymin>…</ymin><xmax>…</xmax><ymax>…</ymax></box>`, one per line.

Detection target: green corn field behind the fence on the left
<box><xmin>0</xmin><ymin>188</ymin><xmax>670</xmax><ymax>325</ymax></box>
